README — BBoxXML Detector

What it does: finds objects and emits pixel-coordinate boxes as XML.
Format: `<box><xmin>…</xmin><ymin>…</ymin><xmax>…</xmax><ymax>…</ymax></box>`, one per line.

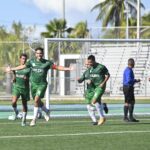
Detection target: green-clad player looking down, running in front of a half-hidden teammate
<box><xmin>88</xmin><ymin>55</ymin><xmax>110</xmax><ymax>125</ymax></box>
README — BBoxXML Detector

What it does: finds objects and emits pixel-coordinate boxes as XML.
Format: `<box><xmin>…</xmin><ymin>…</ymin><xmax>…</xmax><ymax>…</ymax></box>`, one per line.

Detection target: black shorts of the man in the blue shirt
<box><xmin>123</xmin><ymin>85</ymin><xmax>135</xmax><ymax>104</ymax></box>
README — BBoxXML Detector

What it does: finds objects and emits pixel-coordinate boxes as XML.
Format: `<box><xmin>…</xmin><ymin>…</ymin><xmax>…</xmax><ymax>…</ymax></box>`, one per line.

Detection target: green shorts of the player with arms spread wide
<box><xmin>31</xmin><ymin>83</ymin><xmax>47</xmax><ymax>99</ymax></box>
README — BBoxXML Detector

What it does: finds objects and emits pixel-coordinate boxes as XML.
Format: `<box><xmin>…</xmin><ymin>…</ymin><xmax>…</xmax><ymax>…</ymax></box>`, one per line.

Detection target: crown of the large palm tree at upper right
<box><xmin>92</xmin><ymin>0</ymin><xmax>144</xmax><ymax>27</ymax></box>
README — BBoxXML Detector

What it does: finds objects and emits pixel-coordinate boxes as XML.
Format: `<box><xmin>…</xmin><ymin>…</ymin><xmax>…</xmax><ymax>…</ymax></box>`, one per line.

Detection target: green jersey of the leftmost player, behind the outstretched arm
<box><xmin>14</xmin><ymin>68</ymin><xmax>30</xmax><ymax>88</ymax></box>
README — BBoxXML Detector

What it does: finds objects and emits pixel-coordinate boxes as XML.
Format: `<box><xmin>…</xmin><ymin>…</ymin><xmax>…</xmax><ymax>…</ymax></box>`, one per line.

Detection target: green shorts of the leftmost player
<box><xmin>12</xmin><ymin>85</ymin><xmax>30</xmax><ymax>101</ymax></box>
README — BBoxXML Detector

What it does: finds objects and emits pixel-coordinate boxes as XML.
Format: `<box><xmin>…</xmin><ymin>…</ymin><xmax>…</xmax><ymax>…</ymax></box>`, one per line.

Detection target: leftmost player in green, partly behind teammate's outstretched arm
<box><xmin>12</xmin><ymin>53</ymin><xmax>30</xmax><ymax>126</ymax></box>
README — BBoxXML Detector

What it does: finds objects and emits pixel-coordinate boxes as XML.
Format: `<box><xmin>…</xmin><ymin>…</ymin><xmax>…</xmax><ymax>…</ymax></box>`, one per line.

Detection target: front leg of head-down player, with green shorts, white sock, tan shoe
<box><xmin>92</xmin><ymin>87</ymin><xmax>106</xmax><ymax>125</ymax></box>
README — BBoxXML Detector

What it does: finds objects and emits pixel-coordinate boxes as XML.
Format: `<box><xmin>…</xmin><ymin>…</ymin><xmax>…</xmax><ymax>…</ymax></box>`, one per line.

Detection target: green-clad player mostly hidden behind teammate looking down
<box><xmin>77</xmin><ymin>60</ymin><xmax>108</xmax><ymax>125</ymax></box>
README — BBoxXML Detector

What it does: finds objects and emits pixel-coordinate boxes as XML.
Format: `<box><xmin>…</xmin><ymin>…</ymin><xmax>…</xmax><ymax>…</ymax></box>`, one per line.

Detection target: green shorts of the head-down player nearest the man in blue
<box><xmin>92</xmin><ymin>87</ymin><xmax>106</xmax><ymax>102</ymax></box>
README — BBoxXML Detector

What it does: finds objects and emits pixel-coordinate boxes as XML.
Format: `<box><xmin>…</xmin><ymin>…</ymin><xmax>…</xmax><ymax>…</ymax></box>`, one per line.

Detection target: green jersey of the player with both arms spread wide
<box><xmin>26</xmin><ymin>59</ymin><xmax>53</xmax><ymax>84</ymax></box>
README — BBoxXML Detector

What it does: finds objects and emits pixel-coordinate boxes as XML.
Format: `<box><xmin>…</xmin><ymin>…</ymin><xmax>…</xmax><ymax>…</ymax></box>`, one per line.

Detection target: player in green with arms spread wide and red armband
<box><xmin>7</xmin><ymin>47</ymin><xmax>73</xmax><ymax>126</ymax></box>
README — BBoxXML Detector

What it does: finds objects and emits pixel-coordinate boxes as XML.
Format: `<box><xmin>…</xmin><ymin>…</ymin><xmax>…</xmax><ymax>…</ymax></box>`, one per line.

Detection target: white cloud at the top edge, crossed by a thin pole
<box><xmin>27</xmin><ymin>0</ymin><xmax>98</xmax><ymax>14</ymax></box>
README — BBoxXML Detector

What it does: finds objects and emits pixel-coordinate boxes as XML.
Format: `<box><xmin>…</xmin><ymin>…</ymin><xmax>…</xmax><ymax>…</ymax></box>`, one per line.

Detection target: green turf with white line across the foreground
<box><xmin>0</xmin><ymin>117</ymin><xmax>150</xmax><ymax>150</ymax></box>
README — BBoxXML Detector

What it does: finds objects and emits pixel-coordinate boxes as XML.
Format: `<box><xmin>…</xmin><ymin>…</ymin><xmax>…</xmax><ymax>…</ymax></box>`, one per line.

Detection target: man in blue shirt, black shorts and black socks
<box><xmin>123</xmin><ymin>58</ymin><xmax>140</xmax><ymax>122</ymax></box>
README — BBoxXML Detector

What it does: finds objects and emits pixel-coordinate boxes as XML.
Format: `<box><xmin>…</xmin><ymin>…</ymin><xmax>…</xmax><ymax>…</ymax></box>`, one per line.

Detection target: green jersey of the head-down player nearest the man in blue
<box><xmin>90</xmin><ymin>63</ymin><xmax>109</xmax><ymax>87</ymax></box>
